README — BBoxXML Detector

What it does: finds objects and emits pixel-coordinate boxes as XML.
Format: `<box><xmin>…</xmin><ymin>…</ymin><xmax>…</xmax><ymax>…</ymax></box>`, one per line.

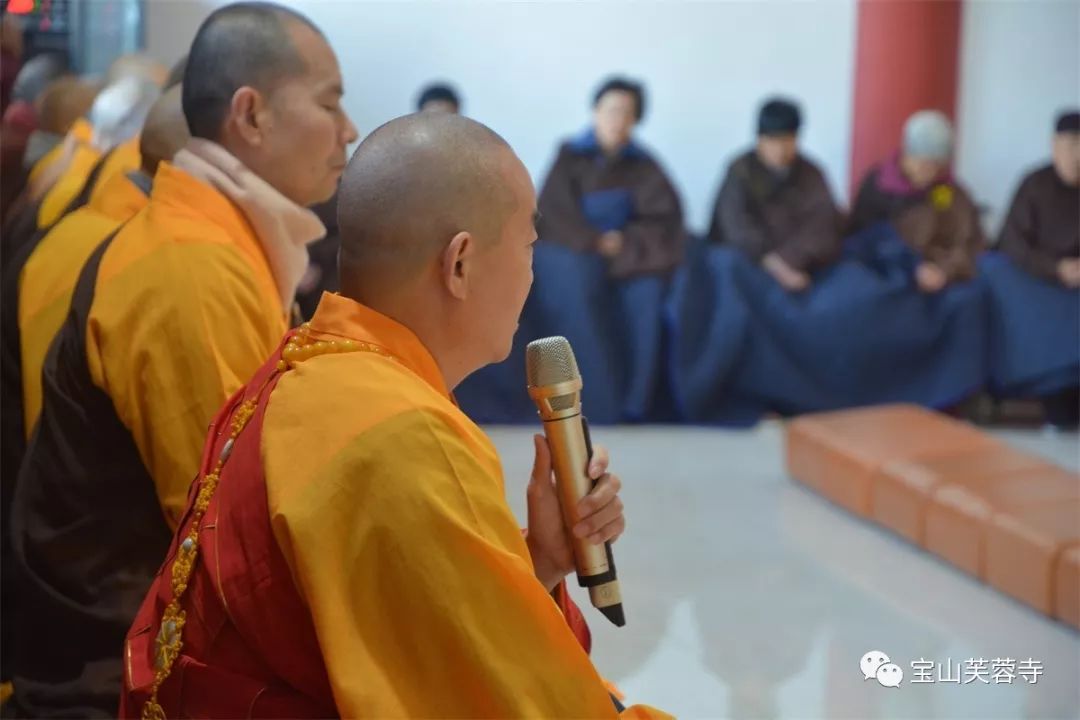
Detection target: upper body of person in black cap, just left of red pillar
<box><xmin>708</xmin><ymin>98</ymin><xmax>840</xmax><ymax>293</ymax></box>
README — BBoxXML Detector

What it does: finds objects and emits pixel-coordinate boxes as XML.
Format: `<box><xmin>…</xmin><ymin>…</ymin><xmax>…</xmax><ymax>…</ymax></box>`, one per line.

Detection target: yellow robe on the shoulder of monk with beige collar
<box><xmin>86</xmin><ymin>163</ymin><xmax>286</xmax><ymax>525</ymax></box>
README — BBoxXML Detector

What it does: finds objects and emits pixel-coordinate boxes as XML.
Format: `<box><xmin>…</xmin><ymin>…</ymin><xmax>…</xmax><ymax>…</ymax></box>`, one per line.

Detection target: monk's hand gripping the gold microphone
<box><xmin>526</xmin><ymin>435</ymin><xmax>626</xmax><ymax>592</ymax></box>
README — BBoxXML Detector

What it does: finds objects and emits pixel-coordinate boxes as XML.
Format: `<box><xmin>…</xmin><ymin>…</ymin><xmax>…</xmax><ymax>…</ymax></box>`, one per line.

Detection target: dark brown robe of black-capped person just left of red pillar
<box><xmin>708</xmin><ymin>151</ymin><xmax>840</xmax><ymax>272</ymax></box>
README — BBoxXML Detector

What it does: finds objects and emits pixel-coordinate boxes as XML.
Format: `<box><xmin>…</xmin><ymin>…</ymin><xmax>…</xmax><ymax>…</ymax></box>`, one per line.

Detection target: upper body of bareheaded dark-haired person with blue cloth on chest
<box><xmin>540</xmin><ymin>78</ymin><xmax>685</xmax><ymax>277</ymax></box>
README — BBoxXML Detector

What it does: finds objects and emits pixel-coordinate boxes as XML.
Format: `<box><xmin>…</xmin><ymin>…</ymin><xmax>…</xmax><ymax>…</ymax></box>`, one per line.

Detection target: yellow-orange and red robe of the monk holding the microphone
<box><xmin>122</xmin><ymin>295</ymin><xmax>666</xmax><ymax>718</ymax></box>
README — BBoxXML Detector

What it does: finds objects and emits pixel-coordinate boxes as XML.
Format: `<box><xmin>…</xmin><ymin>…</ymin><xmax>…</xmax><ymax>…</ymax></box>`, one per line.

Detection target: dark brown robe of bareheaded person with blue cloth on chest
<box><xmin>539</xmin><ymin>142</ymin><xmax>686</xmax><ymax>277</ymax></box>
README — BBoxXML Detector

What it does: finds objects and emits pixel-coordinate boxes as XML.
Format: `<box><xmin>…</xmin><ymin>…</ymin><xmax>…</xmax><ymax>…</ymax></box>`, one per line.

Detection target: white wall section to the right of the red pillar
<box><xmin>957</xmin><ymin>0</ymin><xmax>1080</xmax><ymax>233</ymax></box>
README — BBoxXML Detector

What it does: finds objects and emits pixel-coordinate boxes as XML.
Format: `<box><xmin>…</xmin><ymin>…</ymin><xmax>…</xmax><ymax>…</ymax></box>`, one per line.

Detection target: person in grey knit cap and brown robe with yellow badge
<box><xmin>850</xmin><ymin>110</ymin><xmax>985</xmax><ymax>293</ymax></box>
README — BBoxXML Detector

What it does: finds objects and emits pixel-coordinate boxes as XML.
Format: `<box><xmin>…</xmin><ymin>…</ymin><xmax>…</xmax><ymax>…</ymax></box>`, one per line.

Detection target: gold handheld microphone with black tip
<box><xmin>525</xmin><ymin>337</ymin><xmax>626</xmax><ymax>627</ymax></box>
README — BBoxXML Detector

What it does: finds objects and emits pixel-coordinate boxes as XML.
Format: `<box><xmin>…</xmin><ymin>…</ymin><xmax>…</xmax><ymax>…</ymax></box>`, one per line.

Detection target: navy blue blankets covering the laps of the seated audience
<box><xmin>457</xmin><ymin>222</ymin><xmax>1080</xmax><ymax>426</ymax></box>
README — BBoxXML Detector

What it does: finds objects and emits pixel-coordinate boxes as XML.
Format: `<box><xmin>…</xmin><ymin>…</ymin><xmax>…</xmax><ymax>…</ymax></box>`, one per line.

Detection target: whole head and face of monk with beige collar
<box><xmin>183</xmin><ymin>2</ymin><xmax>356</xmax><ymax>206</ymax></box>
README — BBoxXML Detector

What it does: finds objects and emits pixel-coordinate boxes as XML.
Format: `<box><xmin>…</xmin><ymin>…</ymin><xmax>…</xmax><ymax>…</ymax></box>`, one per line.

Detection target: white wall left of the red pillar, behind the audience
<box><xmin>147</xmin><ymin>0</ymin><xmax>855</xmax><ymax>230</ymax></box>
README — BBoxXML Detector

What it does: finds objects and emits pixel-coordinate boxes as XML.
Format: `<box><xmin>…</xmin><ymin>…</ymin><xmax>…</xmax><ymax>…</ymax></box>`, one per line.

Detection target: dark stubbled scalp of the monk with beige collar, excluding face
<box><xmin>183</xmin><ymin>2</ymin><xmax>322</xmax><ymax>140</ymax></box>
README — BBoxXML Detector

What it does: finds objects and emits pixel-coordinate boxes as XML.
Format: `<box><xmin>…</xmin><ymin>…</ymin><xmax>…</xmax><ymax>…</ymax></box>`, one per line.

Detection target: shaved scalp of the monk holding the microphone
<box><xmin>338</xmin><ymin>113</ymin><xmax>527</xmax><ymax>299</ymax></box>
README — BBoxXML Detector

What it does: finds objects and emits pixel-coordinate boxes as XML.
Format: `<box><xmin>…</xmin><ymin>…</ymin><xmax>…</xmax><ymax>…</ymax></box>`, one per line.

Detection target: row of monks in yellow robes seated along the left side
<box><xmin>0</xmin><ymin>2</ymin><xmax>648</xmax><ymax>718</ymax></box>
